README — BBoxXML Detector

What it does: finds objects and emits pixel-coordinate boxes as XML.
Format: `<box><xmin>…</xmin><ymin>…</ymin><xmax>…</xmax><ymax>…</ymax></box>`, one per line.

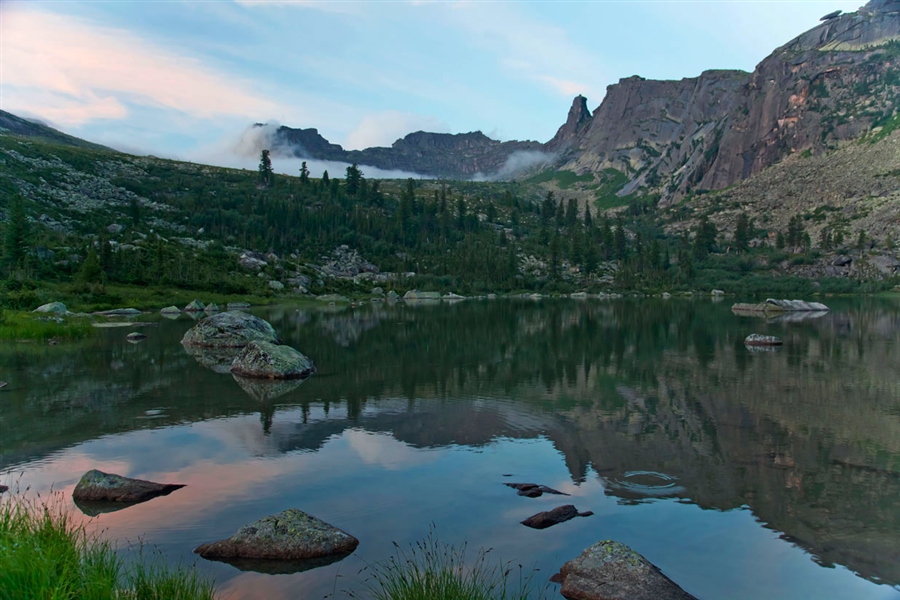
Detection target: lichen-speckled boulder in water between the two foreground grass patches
<box><xmin>194</xmin><ymin>508</ymin><xmax>359</xmax><ymax>560</ymax></box>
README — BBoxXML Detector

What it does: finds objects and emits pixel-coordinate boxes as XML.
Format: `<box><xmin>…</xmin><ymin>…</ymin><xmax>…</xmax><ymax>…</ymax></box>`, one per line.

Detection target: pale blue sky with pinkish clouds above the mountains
<box><xmin>0</xmin><ymin>0</ymin><xmax>864</xmax><ymax>168</ymax></box>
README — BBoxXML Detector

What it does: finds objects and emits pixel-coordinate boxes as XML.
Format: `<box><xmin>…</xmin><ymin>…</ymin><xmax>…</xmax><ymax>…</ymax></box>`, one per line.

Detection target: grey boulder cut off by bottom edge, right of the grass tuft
<box><xmin>552</xmin><ymin>540</ymin><xmax>696</xmax><ymax>600</ymax></box>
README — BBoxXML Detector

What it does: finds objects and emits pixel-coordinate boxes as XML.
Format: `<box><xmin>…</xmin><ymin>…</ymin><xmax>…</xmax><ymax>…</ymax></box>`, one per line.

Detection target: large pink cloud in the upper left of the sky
<box><xmin>0</xmin><ymin>9</ymin><xmax>279</xmax><ymax>125</ymax></box>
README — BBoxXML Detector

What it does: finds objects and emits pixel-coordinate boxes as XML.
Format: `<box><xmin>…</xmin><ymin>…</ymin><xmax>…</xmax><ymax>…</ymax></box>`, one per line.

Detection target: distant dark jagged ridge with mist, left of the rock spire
<box><xmin>258</xmin><ymin>125</ymin><xmax>542</xmax><ymax>179</ymax></box>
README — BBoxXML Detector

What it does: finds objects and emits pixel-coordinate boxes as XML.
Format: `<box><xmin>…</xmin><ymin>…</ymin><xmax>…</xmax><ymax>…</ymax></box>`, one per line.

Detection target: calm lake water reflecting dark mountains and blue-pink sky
<box><xmin>0</xmin><ymin>299</ymin><xmax>900</xmax><ymax>599</ymax></box>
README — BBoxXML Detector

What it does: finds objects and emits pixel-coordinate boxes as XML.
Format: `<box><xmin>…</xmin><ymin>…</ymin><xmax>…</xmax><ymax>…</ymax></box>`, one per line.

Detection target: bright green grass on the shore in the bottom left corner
<box><xmin>0</xmin><ymin>495</ymin><xmax>214</xmax><ymax>600</ymax></box>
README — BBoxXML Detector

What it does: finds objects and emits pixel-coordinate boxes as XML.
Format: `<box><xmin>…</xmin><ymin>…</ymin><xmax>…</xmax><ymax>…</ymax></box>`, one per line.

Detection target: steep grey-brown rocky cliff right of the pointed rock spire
<box><xmin>554</xmin><ymin>0</ymin><xmax>900</xmax><ymax>204</ymax></box>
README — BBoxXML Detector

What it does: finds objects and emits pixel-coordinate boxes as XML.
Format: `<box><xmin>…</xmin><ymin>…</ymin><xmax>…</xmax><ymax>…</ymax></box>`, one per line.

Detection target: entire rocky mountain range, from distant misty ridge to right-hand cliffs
<box><xmin>277</xmin><ymin>0</ymin><xmax>900</xmax><ymax>205</ymax></box>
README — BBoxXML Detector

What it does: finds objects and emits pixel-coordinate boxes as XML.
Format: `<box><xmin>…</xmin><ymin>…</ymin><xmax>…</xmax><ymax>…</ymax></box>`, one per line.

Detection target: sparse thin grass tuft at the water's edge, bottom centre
<box><xmin>350</xmin><ymin>529</ymin><xmax>546</xmax><ymax>600</ymax></box>
